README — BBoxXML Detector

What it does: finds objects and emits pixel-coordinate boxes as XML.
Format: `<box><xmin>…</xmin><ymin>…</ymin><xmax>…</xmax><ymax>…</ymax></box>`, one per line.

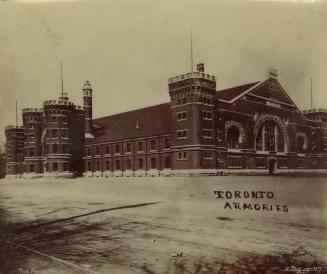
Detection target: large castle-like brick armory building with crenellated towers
<box><xmin>6</xmin><ymin>64</ymin><xmax>327</xmax><ymax>177</ymax></box>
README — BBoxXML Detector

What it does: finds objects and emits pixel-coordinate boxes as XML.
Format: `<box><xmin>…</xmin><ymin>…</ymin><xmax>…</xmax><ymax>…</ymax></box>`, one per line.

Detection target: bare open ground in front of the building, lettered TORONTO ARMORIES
<box><xmin>0</xmin><ymin>176</ymin><xmax>327</xmax><ymax>273</ymax></box>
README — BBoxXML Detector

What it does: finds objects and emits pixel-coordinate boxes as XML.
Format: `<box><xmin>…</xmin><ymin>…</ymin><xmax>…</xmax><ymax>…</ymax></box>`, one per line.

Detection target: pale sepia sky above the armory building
<box><xmin>0</xmin><ymin>0</ymin><xmax>327</xmax><ymax>142</ymax></box>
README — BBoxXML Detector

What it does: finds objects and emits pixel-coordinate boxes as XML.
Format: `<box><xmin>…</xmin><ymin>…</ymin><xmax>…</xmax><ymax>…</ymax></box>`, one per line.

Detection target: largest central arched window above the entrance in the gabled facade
<box><xmin>256</xmin><ymin>120</ymin><xmax>284</xmax><ymax>152</ymax></box>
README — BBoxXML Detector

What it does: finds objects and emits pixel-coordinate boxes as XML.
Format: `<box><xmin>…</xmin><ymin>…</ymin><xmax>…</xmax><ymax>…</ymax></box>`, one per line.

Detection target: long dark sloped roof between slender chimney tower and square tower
<box><xmin>90</xmin><ymin>103</ymin><xmax>171</xmax><ymax>144</ymax></box>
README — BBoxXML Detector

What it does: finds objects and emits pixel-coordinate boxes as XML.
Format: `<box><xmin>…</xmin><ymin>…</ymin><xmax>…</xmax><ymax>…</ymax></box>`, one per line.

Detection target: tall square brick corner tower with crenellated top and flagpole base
<box><xmin>168</xmin><ymin>63</ymin><xmax>216</xmax><ymax>170</ymax></box>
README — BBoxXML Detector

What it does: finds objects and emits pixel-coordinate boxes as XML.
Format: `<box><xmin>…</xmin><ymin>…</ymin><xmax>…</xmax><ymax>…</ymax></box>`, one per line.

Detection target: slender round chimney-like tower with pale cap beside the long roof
<box><xmin>83</xmin><ymin>81</ymin><xmax>94</xmax><ymax>140</ymax></box>
